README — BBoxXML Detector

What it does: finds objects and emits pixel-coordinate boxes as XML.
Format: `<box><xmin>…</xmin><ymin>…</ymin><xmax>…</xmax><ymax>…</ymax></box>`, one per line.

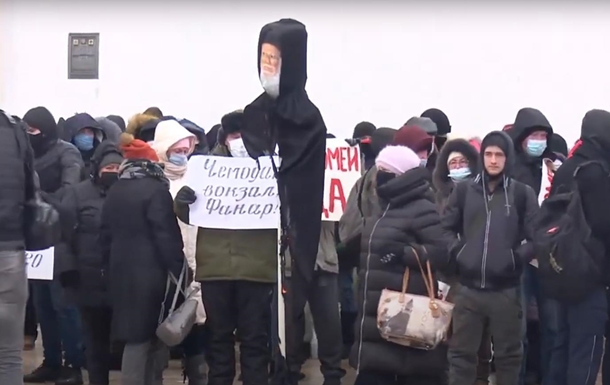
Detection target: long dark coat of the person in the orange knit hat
<box><xmin>99</xmin><ymin>165</ymin><xmax>185</xmax><ymax>343</ymax></box>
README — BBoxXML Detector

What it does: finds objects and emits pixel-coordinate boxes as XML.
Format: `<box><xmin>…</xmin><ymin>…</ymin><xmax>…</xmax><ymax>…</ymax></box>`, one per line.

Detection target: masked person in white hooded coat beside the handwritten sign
<box><xmin>152</xmin><ymin>120</ymin><xmax>207</xmax><ymax>385</ymax></box>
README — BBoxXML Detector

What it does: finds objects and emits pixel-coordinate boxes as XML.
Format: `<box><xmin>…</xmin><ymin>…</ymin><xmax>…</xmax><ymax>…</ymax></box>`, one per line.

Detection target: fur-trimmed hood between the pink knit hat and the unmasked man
<box><xmin>432</xmin><ymin>139</ymin><xmax>479</xmax><ymax>198</ymax></box>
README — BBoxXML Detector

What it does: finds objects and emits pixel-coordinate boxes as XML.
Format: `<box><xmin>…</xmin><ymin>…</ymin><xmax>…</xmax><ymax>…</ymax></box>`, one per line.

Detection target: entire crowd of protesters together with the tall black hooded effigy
<box><xmin>0</xmin><ymin>19</ymin><xmax>610</xmax><ymax>385</ymax></box>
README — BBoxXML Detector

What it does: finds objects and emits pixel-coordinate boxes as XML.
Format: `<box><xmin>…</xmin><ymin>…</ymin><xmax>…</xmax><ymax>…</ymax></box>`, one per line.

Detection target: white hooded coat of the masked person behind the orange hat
<box><xmin>152</xmin><ymin>120</ymin><xmax>205</xmax><ymax>324</ymax></box>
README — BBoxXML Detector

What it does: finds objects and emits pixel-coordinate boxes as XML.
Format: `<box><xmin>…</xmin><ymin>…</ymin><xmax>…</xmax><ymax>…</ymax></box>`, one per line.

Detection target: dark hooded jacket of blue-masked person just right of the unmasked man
<box><xmin>509</xmin><ymin>108</ymin><xmax>557</xmax><ymax>192</ymax></box>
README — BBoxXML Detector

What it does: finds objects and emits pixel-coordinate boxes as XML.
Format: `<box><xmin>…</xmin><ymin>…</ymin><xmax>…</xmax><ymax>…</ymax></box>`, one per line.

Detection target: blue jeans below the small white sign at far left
<box><xmin>32</xmin><ymin>281</ymin><xmax>84</xmax><ymax>368</ymax></box>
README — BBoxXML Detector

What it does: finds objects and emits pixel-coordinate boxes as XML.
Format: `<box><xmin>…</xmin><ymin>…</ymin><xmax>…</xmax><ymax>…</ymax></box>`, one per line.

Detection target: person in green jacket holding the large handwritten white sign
<box><xmin>174</xmin><ymin>111</ymin><xmax>278</xmax><ymax>385</ymax></box>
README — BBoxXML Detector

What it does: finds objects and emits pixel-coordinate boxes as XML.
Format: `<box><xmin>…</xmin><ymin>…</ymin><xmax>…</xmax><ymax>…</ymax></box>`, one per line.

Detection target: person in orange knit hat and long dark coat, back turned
<box><xmin>99</xmin><ymin>133</ymin><xmax>185</xmax><ymax>385</ymax></box>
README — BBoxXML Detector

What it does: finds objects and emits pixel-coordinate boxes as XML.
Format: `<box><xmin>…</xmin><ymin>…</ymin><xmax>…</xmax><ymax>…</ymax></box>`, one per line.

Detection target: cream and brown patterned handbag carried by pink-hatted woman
<box><xmin>377</xmin><ymin>248</ymin><xmax>453</xmax><ymax>350</ymax></box>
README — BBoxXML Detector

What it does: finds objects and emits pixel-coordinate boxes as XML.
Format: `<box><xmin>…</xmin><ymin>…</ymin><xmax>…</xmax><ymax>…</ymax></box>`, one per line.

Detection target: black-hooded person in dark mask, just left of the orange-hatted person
<box><xmin>59</xmin><ymin>141</ymin><xmax>123</xmax><ymax>384</ymax></box>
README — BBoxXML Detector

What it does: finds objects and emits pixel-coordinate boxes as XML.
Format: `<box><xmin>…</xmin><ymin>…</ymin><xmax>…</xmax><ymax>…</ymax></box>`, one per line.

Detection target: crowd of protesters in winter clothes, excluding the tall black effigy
<box><xmin>0</xmin><ymin>100</ymin><xmax>610</xmax><ymax>385</ymax></box>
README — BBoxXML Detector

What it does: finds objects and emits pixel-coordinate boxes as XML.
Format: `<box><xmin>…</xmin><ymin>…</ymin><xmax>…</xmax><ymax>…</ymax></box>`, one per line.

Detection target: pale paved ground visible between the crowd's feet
<box><xmin>23</xmin><ymin>344</ymin><xmax>602</xmax><ymax>385</ymax></box>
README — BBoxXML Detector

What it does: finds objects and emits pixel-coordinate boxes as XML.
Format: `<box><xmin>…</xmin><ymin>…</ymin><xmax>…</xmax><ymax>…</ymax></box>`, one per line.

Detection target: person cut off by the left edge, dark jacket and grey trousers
<box><xmin>0</xmin><ymin>110</ymin><xmax>36</xmax><ymax>385</ymax></box>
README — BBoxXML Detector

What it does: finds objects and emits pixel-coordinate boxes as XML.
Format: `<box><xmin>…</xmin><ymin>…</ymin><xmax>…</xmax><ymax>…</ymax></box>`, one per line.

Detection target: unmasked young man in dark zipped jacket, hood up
<box><xmin>443</xmin><ymin>131</ymin><xmax>538</xmax><ymax>385</ymax></box>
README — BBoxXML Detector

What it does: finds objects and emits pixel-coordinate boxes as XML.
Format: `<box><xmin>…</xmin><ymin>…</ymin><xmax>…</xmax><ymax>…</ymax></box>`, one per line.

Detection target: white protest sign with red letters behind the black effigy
<box><xmin>322</xmin><ymin>139</ymin><xmax>362</xmax><ymax>222</ymax></box>
